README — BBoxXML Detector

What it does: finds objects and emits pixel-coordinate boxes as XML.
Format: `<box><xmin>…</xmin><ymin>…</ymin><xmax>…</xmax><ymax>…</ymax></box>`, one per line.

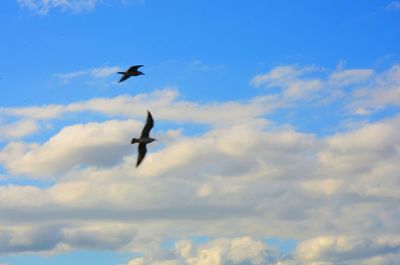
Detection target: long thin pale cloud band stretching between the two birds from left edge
<box><xmin>0</xmin><ymin>88</ymin><xmax>279</xmax><ymax>126</ymax></box>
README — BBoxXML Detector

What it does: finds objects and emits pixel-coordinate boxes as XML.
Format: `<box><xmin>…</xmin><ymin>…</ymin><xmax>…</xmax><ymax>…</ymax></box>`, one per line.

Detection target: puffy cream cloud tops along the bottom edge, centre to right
<box><xmin>119</xmin><ymin>236</ymin><xmax>400</xmax><ymax>265</ymax></box>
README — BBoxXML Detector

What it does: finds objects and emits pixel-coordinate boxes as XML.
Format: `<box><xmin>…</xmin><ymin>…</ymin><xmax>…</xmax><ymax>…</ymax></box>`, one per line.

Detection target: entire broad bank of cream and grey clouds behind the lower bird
<box><xmin>0</xmin><ymin>66</ymin><xmax>400</xmax><ymax>265</ymax></box>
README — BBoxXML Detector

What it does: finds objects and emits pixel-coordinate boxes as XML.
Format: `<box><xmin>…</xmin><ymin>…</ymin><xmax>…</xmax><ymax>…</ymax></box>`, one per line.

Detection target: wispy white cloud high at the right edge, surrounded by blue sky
<box><xmin>251</xmin><ymin>64</ymin><xmax>400</xmax><ymax>115</ymax></box>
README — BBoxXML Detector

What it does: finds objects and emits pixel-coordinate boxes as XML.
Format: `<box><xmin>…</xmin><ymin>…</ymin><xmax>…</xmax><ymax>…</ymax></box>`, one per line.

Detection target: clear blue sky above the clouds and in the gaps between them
<box><xmin>0</xmin><ymin>0</ymin><xmax>400</xmax><ymax>265</ymax></box>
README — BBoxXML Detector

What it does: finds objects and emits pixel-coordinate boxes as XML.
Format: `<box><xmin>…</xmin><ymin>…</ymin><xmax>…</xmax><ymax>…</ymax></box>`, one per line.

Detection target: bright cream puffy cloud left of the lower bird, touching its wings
<box><xmin>0</xmin><ymin>120</ymin><xmax>138</xmax><ymax>176</ymax></box>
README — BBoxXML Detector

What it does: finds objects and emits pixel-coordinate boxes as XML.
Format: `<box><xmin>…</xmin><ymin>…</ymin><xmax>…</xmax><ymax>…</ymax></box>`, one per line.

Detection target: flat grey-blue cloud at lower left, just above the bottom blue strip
<box><xmin>0</xmin><ymin>224</ymin><xmax>135</xmax><ymax>254</ymax></box>
